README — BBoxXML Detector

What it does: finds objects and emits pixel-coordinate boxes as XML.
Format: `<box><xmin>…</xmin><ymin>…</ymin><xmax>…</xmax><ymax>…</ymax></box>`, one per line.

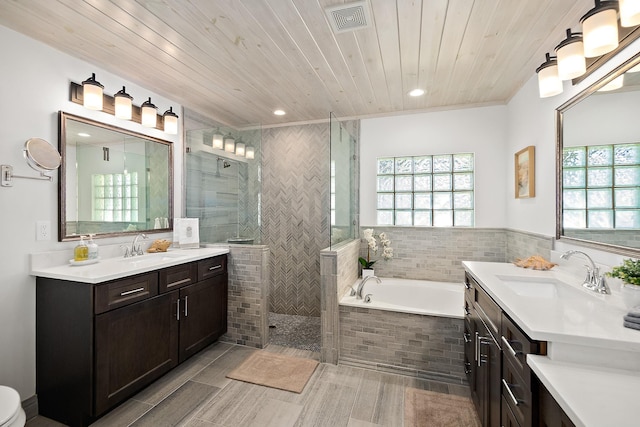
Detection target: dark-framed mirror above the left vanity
<box><xmin>58</xmin><ymin>111</ymin><xmax>173</xmax><ymax>241</ymax></box>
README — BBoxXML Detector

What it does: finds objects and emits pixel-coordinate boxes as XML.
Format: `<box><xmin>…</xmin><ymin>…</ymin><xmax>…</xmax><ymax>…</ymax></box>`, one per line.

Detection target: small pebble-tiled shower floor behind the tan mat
<box><xmin>269</xmin><ymin>313</ymin><xmax>320</xmax><ymax>352</ymax></box>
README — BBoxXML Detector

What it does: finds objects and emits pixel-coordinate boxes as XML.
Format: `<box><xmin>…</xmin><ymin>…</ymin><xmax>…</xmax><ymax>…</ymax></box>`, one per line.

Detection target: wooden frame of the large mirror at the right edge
<box><xmin>556</xmin><ymin>52</ymin><xmax>640</xmax><ymax>258</ymax></box>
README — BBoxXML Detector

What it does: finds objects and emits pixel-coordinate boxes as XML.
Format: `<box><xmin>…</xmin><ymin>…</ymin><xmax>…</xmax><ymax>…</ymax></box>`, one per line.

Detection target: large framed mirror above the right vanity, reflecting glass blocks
<box><xmin>556</xmin><ymin>54</ymin><xmax>640</xmax><ymax>257</ymax></box>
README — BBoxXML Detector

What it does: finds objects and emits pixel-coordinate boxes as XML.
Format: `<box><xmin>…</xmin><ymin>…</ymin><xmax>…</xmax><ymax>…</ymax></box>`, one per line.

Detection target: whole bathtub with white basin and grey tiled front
<box><xmin>338</xmin><ymin>278</ymin><xmax>467</xmax><ymax>386</ymax></box>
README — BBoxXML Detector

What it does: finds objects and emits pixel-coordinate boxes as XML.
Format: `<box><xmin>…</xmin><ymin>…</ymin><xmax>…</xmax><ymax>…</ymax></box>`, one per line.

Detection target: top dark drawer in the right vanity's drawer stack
<box><xmin>501</xmin><ymin>313</ymin><xmax>547</xmax><ymax>379</ymax></box>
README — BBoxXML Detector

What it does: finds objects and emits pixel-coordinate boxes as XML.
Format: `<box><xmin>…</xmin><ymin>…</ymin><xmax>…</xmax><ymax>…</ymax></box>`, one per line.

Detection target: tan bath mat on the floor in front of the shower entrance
<box><xmin>227</xmin><ymin>351</ymin><xmax>318</xmax><ymax>393</ymax></box>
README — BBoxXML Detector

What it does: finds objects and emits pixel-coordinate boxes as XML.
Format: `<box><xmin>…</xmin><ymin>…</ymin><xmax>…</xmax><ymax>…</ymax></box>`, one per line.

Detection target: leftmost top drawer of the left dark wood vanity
<box><xmin>95</xmin><ymin>272</ymin><xmax>158</xmax><ymax>314</ymax></box>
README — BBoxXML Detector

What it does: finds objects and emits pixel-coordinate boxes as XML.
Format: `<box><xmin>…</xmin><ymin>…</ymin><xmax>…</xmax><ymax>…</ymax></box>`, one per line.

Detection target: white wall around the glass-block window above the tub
<box><xmin>360</xmin><ymin>105</ymin><xmax>511</xmax><ymax>227</ymax></box>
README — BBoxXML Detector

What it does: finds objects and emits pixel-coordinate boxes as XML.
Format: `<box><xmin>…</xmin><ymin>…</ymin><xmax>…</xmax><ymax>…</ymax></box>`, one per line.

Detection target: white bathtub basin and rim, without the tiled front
<box><xmin>340</xmin><ymin>277</ymin><xmax>464</xmax><ymax>319</ymax></box>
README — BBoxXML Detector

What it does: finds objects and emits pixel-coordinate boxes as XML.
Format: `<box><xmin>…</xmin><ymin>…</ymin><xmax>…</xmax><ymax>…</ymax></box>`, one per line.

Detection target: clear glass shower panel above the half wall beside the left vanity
<box><xmin>185</xmin><ymin>127</ymin><xmax>262</xmax><ymax>244</ymax></box>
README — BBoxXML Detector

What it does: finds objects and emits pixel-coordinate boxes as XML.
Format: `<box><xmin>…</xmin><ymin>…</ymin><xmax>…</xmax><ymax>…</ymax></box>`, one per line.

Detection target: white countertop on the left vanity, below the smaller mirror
<box><xmin>31</xmin><ymin>247</ymin><xmax>229</xmax><ymax>283</ymax></box>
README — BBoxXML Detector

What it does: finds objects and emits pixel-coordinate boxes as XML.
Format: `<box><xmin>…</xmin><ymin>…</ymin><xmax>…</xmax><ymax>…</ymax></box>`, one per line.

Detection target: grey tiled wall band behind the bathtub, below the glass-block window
<box><xmin>359</xmin><ymin>226</ymin><xmax>553</xmax><ymax>283</ymax></box>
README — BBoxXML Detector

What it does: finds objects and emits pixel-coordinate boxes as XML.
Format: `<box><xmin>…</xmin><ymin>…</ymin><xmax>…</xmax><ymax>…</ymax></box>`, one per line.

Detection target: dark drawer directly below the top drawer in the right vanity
<box><xmin>502</xmin><ymin>357</ymin><xmax>533</xmax><ymax>427</ymax></box>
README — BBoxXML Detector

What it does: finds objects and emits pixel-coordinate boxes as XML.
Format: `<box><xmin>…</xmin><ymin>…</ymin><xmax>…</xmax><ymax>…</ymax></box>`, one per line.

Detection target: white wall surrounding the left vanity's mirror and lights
<box><xmin>0</xmin><ymin>26</ymin><xmax>183</xmax><ymax>400</ymax></box>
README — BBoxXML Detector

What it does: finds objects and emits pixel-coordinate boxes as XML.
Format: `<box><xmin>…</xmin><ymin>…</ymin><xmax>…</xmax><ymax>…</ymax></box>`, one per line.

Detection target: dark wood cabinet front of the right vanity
<box><xmin>465</xmin><ymin>273</ymin><xmax>546</xmax><ymax>427</ymax></box>
